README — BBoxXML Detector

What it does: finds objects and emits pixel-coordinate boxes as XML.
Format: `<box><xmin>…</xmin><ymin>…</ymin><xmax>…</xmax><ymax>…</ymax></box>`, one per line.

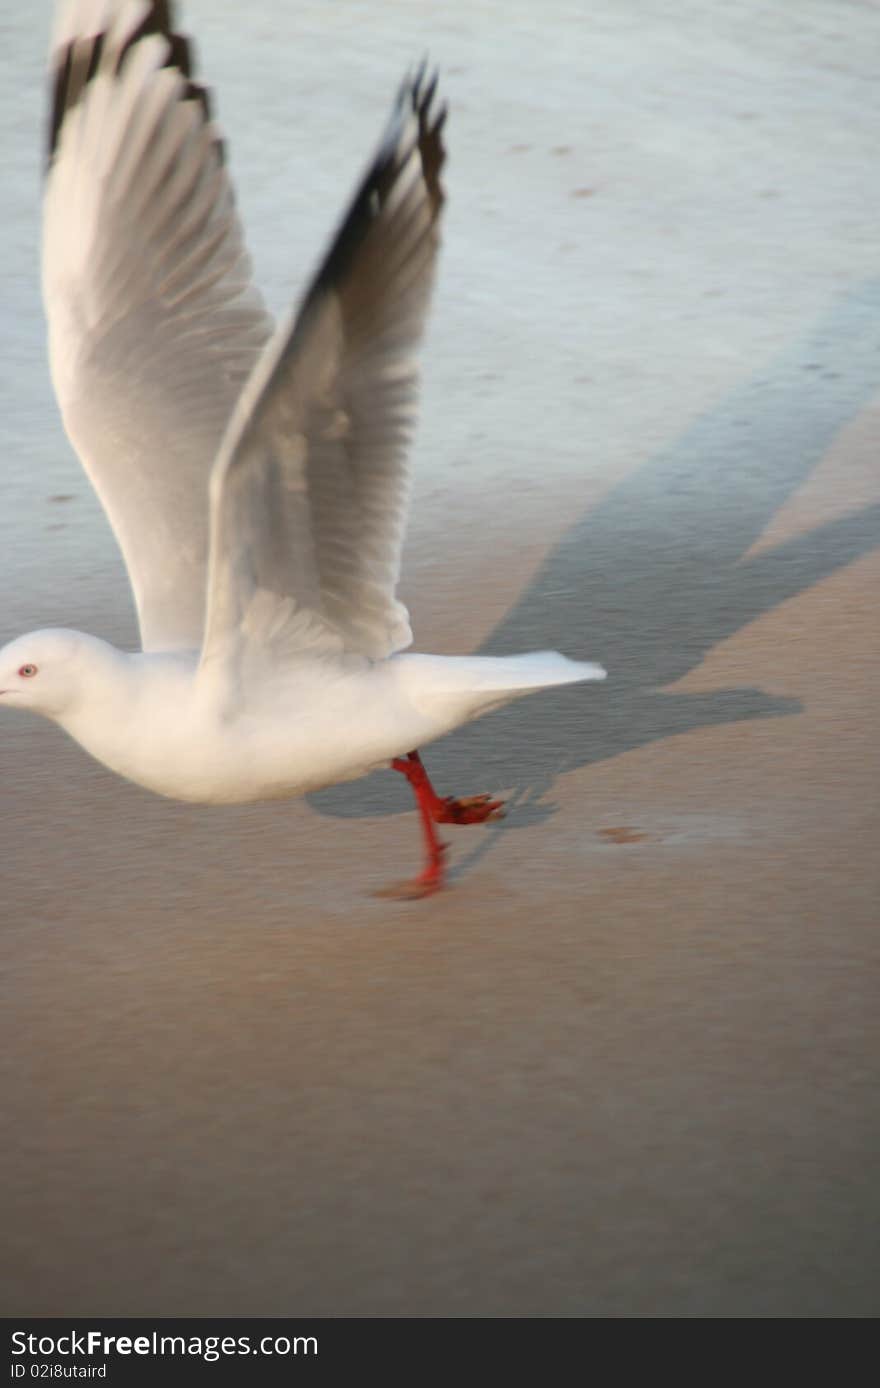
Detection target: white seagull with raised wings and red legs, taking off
<box><xmin>0</xmin><ymin>0</ymin><xmax>605</xmax><ymax>898</ymax></box>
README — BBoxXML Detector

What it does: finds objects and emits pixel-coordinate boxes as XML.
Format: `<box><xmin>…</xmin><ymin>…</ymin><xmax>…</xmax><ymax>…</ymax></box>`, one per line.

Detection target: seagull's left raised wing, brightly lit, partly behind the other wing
<box><xmin>43</xmin><ymin>0</ymin><xmax>272</xmax><ymax>650</ymax></box>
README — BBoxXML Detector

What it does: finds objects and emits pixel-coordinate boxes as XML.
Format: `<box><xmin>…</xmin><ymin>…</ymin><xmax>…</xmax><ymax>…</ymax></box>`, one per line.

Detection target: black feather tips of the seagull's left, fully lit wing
<box><xmin>47</xmin><ymin>0</ymin><xmax>216</xmax><ymax>167</ymax></box>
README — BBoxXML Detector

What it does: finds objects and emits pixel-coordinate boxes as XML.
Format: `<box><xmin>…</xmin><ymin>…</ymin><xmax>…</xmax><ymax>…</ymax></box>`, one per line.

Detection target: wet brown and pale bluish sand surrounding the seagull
<box><xmin>0</xmin><ymin>0</ymin><xmax>880</xmax><ymax>1317</ymax></box>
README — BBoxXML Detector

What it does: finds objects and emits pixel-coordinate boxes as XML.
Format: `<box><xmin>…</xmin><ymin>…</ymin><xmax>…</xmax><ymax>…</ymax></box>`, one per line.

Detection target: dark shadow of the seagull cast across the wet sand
<box><xmin>308</xmin><ymin>280</ymin><xmax>880</xmax><ymax>872</ymax></box>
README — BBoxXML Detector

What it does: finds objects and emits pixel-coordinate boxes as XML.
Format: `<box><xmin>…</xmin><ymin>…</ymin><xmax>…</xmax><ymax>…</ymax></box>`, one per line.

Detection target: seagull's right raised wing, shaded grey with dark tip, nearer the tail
<box><xmin>203</xmin><ymin>71</ymin><xmax>446</xmax><ymax>677</ymax></box>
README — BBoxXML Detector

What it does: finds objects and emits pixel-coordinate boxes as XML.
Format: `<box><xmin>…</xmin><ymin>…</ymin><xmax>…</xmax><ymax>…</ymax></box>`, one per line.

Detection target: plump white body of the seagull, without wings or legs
<box><xmin>13</xmin><ymin>630</ymin><xmax>594</xmax><ymax>805</ymax></box>
